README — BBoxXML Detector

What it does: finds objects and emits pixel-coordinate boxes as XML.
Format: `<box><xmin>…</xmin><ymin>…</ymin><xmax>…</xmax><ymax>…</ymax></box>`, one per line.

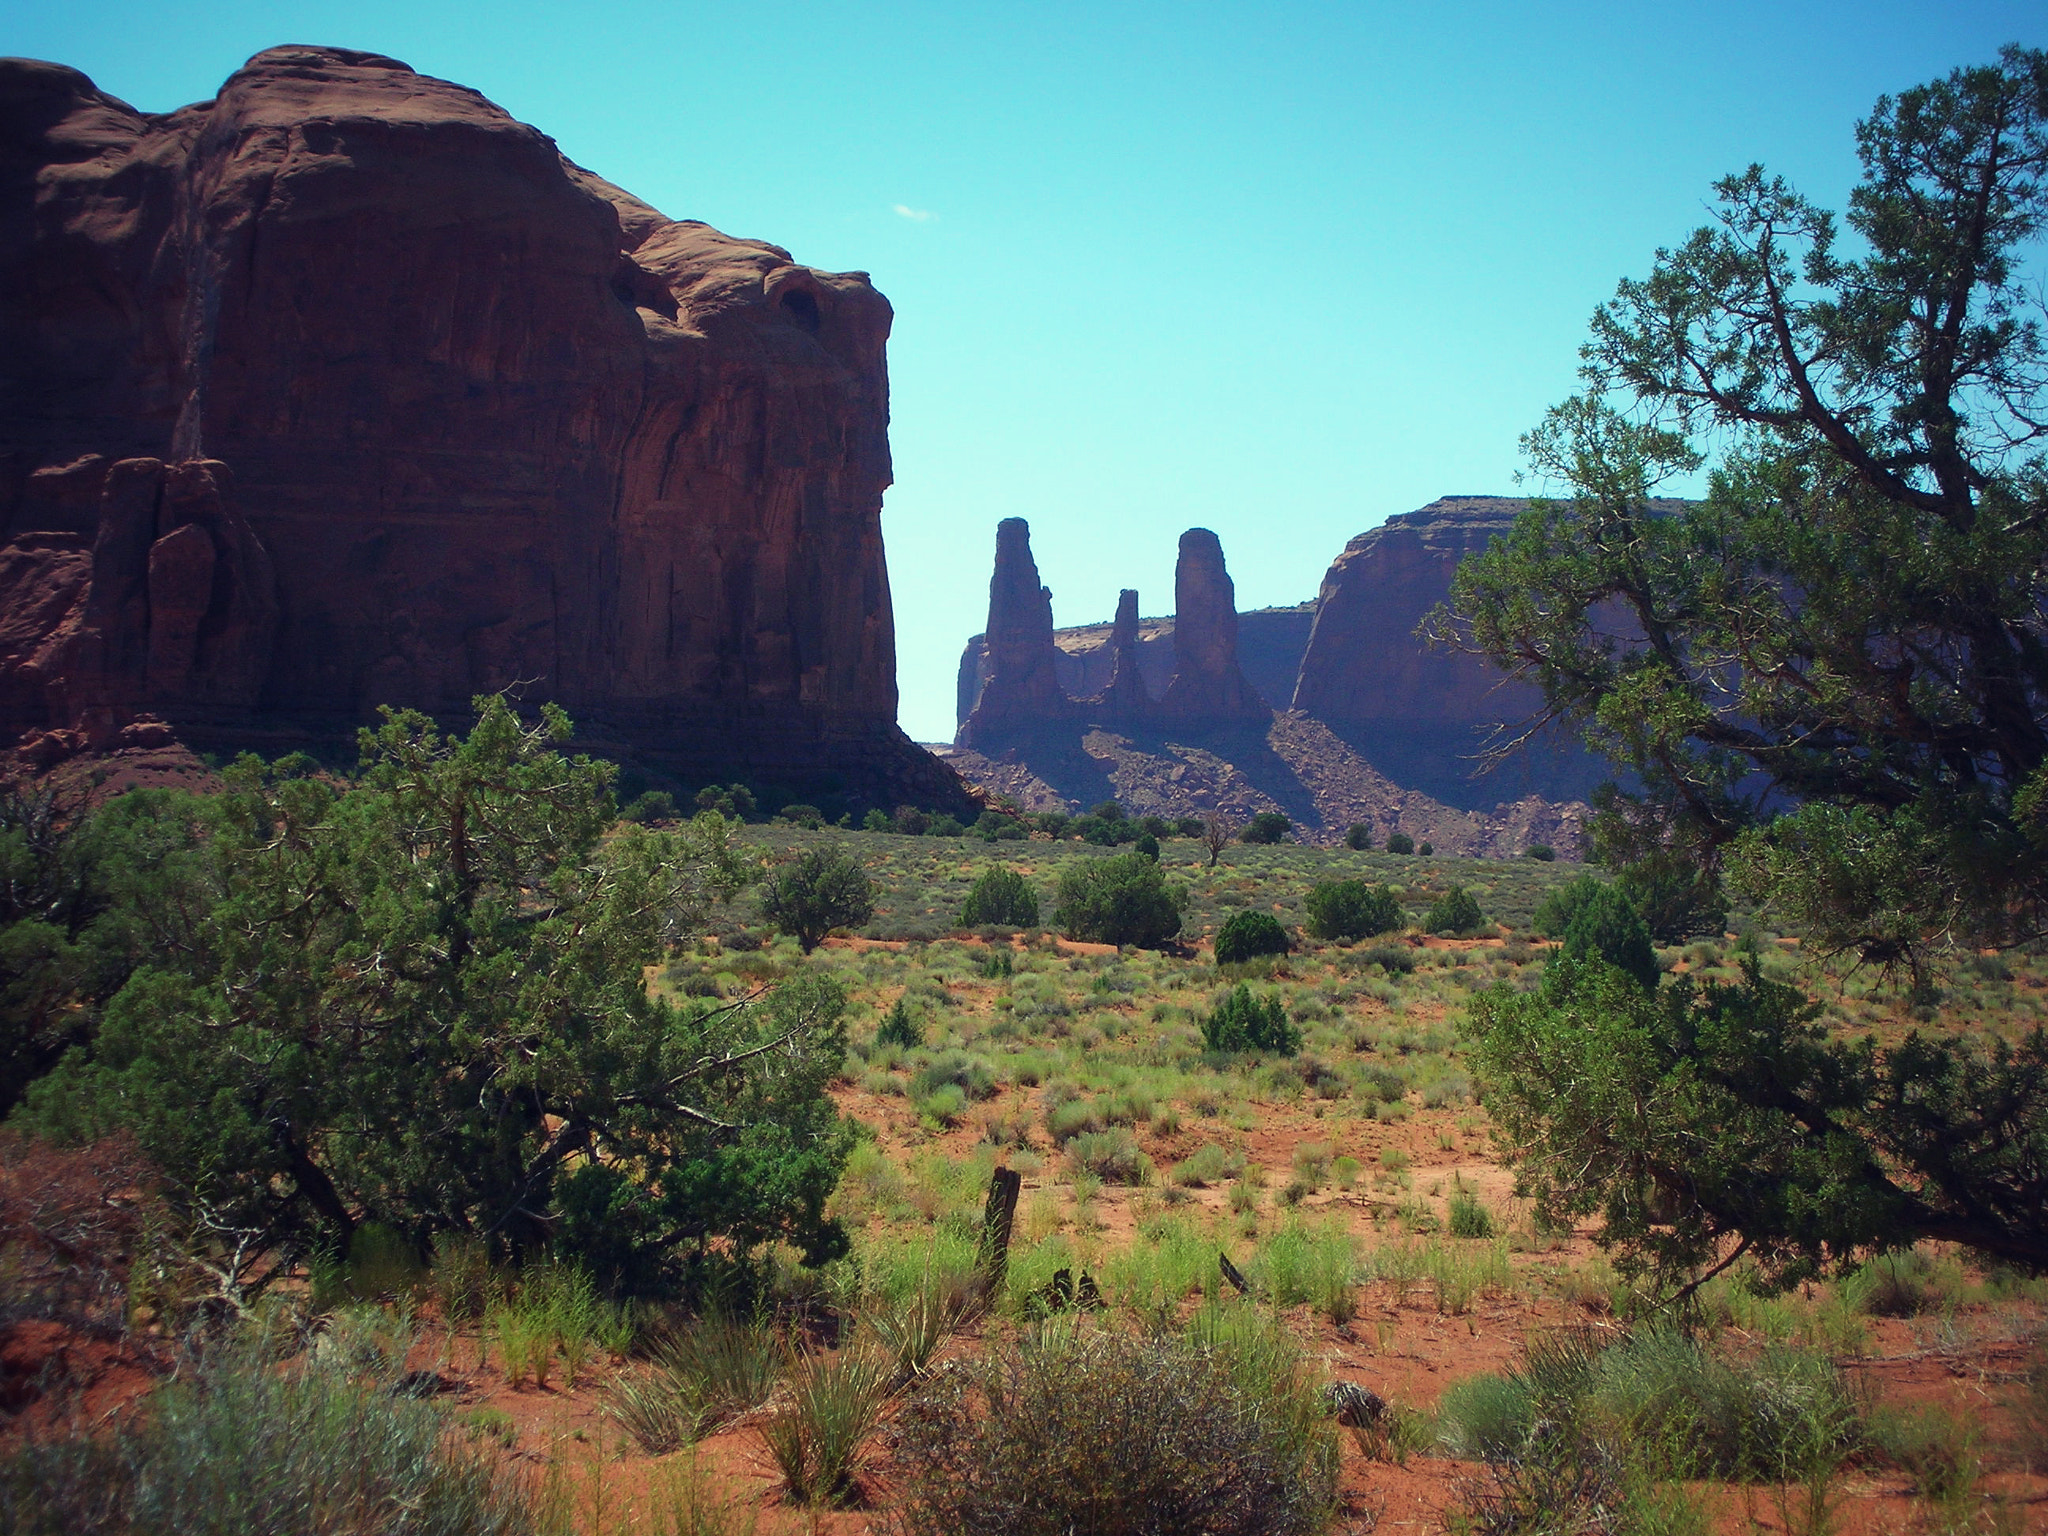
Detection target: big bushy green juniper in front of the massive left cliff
<box><xmin>18</xmin><ymin>696</ymin><xmax>848</xmax><ymax>1286</ymax></box>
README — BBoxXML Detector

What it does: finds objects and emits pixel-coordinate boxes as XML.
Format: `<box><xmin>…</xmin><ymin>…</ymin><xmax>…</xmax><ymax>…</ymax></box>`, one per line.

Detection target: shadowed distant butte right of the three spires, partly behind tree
<box><xmin>1292</xmin><ymin>496</ymin><xmax>1675</xmax><ymax>809</ymax></box>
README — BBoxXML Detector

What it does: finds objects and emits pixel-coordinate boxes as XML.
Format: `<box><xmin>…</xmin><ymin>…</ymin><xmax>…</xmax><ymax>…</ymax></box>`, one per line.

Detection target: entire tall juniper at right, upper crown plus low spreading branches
<box><xmin>1436</xmin><ymin>47</ymin><xmax>2048</xmax><ymax>1284</ymax></box>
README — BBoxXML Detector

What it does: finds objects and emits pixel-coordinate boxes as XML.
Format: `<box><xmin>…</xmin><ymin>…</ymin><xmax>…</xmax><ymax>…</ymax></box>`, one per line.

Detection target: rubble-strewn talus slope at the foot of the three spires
<box><xmin>944</xmin><ymin>711</ymin><xmax>1587</xmax><ymax>858</ymax></box>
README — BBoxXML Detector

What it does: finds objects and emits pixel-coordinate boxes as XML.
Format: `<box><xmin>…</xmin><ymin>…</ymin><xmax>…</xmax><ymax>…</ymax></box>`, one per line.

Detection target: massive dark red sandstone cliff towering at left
<box><xmin>0</xmin><ymin>47</ymin><xmax>942</xmax><ymax>798</ymax></box>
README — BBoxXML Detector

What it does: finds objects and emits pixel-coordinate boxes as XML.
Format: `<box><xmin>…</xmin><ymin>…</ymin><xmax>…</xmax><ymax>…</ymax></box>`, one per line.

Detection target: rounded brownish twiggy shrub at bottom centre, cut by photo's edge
<box><xmin>897</xmin><ymin>1327</ymin><xmax>1337</xmax><ymax>1536</ymax></box>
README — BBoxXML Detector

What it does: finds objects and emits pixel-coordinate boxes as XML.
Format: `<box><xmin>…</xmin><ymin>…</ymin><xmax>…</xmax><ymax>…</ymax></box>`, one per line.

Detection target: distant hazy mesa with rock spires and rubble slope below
<box><xmin>952</xmin><ymin>496</ymin><xmax>1665</xmax><ymax>852</ymax></box>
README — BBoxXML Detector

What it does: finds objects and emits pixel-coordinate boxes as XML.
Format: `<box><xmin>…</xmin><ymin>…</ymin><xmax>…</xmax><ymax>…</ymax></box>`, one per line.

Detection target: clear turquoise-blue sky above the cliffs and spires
<box><xmin>0</xmin><ymin>0</ymin><xmax>2048</xmax><ymax>739</ymax></box>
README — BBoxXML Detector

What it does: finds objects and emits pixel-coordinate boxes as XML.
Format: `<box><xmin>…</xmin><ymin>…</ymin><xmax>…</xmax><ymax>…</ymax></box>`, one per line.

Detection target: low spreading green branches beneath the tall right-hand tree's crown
<box><xmin>1475</xmin><ymin>954</ymin><xmax>2048</xmax><ymax>1290</ymax></box>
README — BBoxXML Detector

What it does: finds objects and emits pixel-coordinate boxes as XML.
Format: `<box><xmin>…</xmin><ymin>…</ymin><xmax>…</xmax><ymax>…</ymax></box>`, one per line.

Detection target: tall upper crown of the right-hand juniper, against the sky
<box><xmin>1438</xmin><ymin>47</ymin><xmax>2048</xmax><ymax>967</ymax></box>
